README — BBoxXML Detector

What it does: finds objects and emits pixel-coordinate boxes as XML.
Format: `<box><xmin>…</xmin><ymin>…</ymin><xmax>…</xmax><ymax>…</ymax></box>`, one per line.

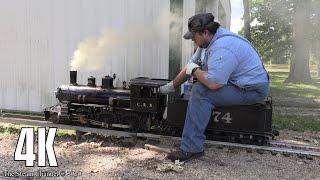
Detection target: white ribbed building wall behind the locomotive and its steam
<box><xmin>0</xmin><ymin>0</ymin><xmax>169</xmax><ymax>111</ymax></box>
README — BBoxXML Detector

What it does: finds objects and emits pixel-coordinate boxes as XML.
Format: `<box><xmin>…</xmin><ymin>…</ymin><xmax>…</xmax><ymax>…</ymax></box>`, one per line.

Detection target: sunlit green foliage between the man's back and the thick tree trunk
<box><xmin>251</xmin><ymin>0</ymin><xmax>293</xmax><ymax>64</ymax></box>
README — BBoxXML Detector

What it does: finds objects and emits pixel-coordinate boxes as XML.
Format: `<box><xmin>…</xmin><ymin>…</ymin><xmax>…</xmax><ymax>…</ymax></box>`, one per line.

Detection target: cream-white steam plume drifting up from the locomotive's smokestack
<box><xmin>70</xmin><ymin>5</ymin><xmax>178</xmax><ymax>72</ymax></box>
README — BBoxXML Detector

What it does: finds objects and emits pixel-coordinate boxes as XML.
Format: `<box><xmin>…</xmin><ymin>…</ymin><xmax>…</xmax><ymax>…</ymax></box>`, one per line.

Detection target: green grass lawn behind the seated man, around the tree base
<box><xmin>266</xmin><ymin>64</ymin><xmax>320</xmax><ymax>132</ymax></box>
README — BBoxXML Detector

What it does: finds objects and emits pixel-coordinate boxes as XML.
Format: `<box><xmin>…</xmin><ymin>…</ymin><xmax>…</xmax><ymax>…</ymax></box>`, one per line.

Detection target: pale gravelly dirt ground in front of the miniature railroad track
<box><xmin>0</xmin><ymin>131</ymin><xmax>320</xmax><ymax>179</ymax></box>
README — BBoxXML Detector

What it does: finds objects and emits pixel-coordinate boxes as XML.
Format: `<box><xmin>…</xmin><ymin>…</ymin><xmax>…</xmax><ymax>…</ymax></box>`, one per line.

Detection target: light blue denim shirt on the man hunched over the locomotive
<box><xmin>190</xmin><ymin>28</ymin><xmax>269</xmax><ymax>88</ymax></box>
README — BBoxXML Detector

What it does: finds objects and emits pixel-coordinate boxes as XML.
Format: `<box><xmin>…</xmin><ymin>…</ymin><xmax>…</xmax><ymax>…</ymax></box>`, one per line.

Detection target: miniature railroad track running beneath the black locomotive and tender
<box><xmin>0</xmin><ymin>116</ymin><xmax>320</xmax><ymax>157</ymax></box>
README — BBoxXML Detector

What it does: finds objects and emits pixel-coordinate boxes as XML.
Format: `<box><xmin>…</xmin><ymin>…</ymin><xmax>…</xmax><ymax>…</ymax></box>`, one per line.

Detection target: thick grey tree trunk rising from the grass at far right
<box><xmin>285</xmin><ymin>1</ymin><xmax>311</xmax><ymax>83</ymax></box>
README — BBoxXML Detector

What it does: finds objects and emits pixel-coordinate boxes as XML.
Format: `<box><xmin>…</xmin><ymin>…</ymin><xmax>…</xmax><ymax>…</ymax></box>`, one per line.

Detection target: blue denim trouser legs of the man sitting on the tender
<box><xmin>180</xmin><ymin>82</ymin><xmax>269</xmax><ymax>152</ymax></box>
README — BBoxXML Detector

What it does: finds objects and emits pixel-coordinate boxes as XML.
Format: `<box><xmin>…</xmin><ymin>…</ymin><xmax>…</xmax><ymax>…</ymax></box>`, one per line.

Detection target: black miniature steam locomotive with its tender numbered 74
<box><xmin>44</xmin><ymin>71</ymin><xmax>277</xmax><ymax>145</ymax></box>
